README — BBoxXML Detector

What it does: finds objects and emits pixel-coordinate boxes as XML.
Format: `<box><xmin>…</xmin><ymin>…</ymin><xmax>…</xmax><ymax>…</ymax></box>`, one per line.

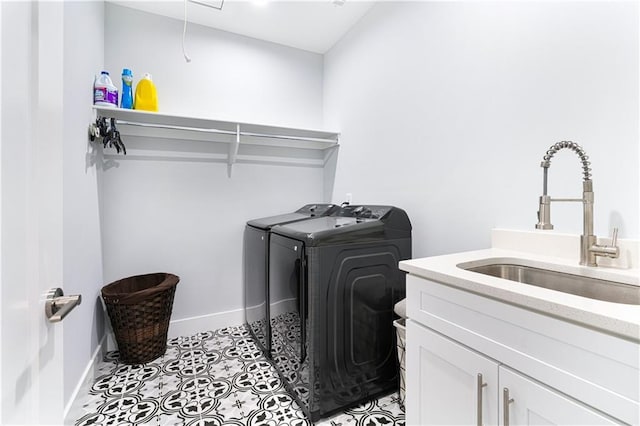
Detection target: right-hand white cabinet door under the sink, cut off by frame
<box><xmin>499</xmin><ymin>366</ymin><xmax>620</xmax><ymax>426</ymax></box>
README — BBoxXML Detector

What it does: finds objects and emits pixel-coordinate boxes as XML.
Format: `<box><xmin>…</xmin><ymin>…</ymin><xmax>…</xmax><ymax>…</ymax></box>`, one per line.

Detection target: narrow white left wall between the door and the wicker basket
<box><xmin>62</xmin><ymin>1</ymin><xmax>105</xmax><ymax>412</ymax></box>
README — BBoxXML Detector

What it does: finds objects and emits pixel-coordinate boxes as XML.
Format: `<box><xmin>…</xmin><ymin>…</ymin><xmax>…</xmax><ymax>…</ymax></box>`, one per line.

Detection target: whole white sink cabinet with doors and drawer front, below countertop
<box><xmin>406</xmin><ymin>275</ymin><xmax>640</xmax><ymax>426</ymax></box>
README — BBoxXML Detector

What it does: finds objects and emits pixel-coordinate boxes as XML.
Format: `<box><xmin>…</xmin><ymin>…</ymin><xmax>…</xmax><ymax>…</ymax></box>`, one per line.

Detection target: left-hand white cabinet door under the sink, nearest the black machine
<box><xmin>406</xmin><ymin>320</ymin><xmax>498</xmax><ymax>425</ymax></box>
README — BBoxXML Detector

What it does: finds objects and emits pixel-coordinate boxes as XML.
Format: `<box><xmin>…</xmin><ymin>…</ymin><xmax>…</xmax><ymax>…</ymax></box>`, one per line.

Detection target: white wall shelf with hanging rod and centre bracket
<box><xmin>93</xmin><ymin>106</ymin><xmax>340</xmax><ymax>176</ymax></box>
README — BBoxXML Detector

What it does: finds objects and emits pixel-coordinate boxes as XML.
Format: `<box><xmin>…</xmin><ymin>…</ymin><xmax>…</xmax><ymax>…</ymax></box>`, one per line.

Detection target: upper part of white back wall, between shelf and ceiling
<box><xmin>105</xmin><ymin>3</ymin><xmax>322</xmax><ymax>128</ymax></box>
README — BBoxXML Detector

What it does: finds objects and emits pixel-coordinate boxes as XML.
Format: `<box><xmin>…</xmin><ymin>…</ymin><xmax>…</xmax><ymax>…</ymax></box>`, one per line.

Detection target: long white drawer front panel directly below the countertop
<box><xmin>407</xmin><ymin>275</ymin><xmax>640</xmax><ymax>424</ymax></box>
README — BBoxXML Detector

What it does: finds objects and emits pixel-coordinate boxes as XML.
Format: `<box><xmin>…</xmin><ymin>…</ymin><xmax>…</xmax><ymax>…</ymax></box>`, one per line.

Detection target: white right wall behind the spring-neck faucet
<box><xmin>324</xmin><ymin>2</ymin><xmax>640</xmax><ymax>257</ymax></box>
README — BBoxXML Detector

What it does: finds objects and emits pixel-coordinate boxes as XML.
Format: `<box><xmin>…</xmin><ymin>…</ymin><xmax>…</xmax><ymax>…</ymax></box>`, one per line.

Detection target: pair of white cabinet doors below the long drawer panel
<box><xmin>406</xmin><ymin>321</ymin><xmax>618</xmax><ymax>426</ymax></box>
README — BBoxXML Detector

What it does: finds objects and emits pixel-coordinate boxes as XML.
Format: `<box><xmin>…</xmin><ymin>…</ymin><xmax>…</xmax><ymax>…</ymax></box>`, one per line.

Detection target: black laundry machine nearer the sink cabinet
<box><xmin>269</xmin><ymin>206</ymin><xmax>411</xmax><ymax>422</ymax></box>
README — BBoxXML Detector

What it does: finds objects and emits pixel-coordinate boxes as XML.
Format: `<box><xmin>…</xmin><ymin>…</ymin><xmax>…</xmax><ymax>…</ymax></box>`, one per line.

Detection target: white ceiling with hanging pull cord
<box><xmin>107</xmin><ymin>0</ymin><xmax>374</xmax><ymax>53</ymax></box>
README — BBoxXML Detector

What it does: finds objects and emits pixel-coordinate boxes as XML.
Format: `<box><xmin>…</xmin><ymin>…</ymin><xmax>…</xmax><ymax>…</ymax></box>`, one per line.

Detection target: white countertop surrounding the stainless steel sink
<box><xmin>400</xmin><ymin>231</ymin><xmax>640</xmax><ymax>342</ymax></box>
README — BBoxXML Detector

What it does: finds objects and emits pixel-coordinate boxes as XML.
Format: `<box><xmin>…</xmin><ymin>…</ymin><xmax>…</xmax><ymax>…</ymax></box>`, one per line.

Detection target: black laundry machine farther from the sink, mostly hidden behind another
<box><xmin>243</xmin><ymin>204</ymin><xmax>339</xmax><ymax>357</ymax></box>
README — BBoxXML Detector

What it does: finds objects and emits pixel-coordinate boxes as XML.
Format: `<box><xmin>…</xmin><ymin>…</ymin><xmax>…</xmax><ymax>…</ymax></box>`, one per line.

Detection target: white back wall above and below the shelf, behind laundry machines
<box><xmin>102</xmin><ymin>4</ymin><xmax>323</xmax><ymax>326</ymax></box>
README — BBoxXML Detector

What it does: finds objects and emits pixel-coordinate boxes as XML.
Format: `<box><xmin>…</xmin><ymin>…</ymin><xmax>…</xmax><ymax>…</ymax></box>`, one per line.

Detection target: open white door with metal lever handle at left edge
<box><xmin>0</xmin><ymin>1</ymin><xmax>64</xmax><ymax>424</ymax></box>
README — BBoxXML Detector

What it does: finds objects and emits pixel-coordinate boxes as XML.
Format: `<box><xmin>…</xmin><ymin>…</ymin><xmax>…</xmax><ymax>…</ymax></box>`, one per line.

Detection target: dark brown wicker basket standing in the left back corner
<box><xmin>102</xmin><ymin>273</ymin><xmax>180</xmax><ymax>364</ymax></box>
